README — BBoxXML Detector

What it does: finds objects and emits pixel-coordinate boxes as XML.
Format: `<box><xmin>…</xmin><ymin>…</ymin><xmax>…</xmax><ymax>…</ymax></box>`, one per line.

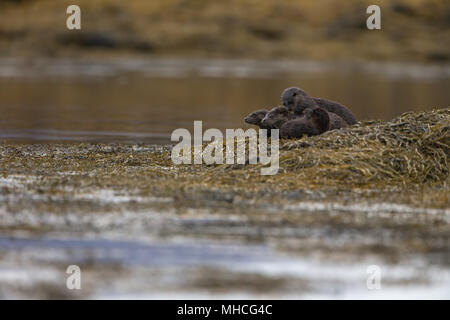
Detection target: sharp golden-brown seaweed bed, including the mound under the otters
<box><xmin>0</xmin><ymin>109</ymin><xmax>450</xmax><ymax>207</ymax></box>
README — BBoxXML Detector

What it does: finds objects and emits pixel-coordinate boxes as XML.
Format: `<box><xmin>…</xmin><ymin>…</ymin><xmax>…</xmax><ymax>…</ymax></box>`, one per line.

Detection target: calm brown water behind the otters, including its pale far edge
<box><xmin>0</xmin><ymin>60</ymin><xmax>450</xmax><ymax>143</ymax></box>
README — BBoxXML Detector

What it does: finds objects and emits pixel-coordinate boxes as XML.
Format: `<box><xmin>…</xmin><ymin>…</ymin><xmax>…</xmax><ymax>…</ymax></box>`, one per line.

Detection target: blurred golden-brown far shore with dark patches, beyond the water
<box><xmin>0</xmin><ymin>0</ymin><xmax>450</xmax><ymax>62</ymax></box>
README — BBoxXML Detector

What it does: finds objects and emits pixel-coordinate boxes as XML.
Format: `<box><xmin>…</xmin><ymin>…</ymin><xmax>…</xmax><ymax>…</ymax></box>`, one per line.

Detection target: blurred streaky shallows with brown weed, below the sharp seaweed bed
<box><xmin>0</xmin><ymin>168</ymin><xmax>450</xmax><ymax>299</ymax></box>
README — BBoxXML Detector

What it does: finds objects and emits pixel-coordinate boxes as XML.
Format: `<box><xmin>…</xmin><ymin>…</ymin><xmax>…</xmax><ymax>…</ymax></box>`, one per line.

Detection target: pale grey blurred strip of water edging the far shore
<box><xmin>0</xmin><ymin>57</ymin><xmax>450</xmax><ymax>80</ymax></box>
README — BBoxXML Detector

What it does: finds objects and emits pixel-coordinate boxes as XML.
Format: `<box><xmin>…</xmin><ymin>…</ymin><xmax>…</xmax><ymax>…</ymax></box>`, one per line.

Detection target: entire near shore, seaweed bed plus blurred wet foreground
<box><xmin>0</xmin><ymin>109</ymin><xmax>450</xmax><ymax>299</ymax></box>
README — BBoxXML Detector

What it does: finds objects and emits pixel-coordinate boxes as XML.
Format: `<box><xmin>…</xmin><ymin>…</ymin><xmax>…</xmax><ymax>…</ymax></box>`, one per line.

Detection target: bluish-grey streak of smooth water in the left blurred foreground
<box><xmin>0</xmin><ymin>237</ymin><xmax>272</xmax><ymax>267</ymax></box>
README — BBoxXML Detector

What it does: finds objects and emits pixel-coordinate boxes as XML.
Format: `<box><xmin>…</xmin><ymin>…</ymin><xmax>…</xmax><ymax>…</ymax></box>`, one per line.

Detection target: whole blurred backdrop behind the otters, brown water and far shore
<box><xmin>0</xmin><ymin>0</ymin><xmax>450</xmax><ymax>143</ymax></box>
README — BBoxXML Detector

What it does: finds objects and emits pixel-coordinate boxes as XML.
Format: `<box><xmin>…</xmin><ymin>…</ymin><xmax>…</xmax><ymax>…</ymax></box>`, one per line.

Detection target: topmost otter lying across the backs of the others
<box><xmin>281</xmin><ymin>87</ymin><xmax>357</xmax><ymax>125</ymax></box>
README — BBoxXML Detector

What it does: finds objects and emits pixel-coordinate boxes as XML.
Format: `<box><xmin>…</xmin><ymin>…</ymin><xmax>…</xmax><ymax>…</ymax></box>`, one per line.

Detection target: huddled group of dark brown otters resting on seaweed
<box><xmin>244</xmin><ymin>87</ymin><xmax>357</xmax><ymax>139</ymax></box>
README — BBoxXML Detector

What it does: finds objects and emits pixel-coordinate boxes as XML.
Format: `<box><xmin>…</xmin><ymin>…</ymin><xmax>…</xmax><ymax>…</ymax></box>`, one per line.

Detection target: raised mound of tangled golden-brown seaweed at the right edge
<box><xmin>274</xmin><ymin>109</ymin><xmax>450</xmax><ymax>187</ymax></box>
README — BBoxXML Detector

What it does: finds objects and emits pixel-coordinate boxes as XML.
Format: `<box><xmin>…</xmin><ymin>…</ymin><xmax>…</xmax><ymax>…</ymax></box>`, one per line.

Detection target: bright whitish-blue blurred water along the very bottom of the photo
<box><xmin>0</xmin><ymin>237</ymin><xmax>450</xmax><ymax>299</ymax></box>
